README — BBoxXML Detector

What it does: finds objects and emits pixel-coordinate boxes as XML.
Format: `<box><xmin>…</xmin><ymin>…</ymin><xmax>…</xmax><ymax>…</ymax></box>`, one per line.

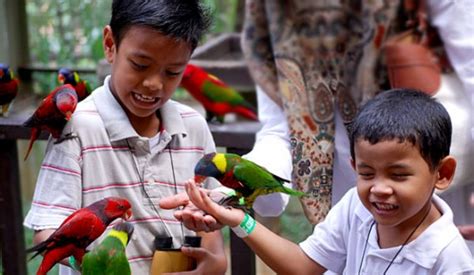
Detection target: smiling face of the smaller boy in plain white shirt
<box><xmin>353</xmin><ymin>139</ymin><xmax>449</xmax><ymax>231</ymax></box>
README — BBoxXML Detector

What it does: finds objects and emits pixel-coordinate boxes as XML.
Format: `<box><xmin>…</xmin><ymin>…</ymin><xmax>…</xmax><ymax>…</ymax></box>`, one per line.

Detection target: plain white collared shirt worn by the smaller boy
<box><xmin>300</xmin><ymin>188</ymin><xmax>474</xmax><ymax>275</ymax></box>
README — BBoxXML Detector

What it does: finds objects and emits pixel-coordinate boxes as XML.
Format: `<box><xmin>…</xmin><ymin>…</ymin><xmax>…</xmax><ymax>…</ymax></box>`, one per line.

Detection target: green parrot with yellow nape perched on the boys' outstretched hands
<box><xmin>194</xmin><ymin>153</ymin><xmax>304</xmax><ymax>209</ymax></box>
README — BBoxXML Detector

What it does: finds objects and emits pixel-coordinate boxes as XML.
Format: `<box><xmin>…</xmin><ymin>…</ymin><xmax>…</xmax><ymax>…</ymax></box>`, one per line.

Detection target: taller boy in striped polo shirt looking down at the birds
<box><xmin>24</xmin><ymin>0</ymin><xmax>227</xmax><ymax>274</ymax></box>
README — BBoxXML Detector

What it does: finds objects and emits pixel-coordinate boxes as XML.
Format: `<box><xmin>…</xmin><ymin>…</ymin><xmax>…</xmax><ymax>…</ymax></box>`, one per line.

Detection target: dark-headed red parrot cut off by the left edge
<box><xmin>0</xmin><ymin>63</ymin><xmax>20</xmax><ymax>116</ymax></box>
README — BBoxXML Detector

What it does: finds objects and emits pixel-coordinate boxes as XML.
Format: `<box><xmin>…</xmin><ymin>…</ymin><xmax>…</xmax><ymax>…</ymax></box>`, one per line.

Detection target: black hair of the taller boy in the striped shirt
<box><xmin>109</xmin><ymin>0</ymin><xmax>211</xmax><ymax>50</ymax></box>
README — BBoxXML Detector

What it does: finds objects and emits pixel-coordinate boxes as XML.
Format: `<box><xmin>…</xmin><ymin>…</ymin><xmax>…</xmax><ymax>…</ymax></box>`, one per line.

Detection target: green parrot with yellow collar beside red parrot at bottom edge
<box><xmin>81</xmin><ymin>222</ymin><xmax>133</xmax><ymax>275</ymax></box>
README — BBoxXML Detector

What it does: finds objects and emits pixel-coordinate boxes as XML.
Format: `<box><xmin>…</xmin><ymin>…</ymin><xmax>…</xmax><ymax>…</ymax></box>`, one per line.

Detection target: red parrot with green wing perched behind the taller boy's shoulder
<box><xmin>181</xmin><ymin>64</ymin><xmax>258</xmax><ymax>123</ymax></box>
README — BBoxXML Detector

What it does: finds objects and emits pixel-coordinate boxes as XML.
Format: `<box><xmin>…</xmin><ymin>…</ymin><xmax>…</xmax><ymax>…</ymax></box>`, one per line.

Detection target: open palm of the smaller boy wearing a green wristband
<box><xmin>186</xmin><ymin>180</ymin><xmax>245</xmax><ymax>227</ymax></box>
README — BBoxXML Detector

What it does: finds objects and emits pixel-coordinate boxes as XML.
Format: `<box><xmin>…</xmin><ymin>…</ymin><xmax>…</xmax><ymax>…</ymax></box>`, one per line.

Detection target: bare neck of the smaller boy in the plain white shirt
<box><xmin>377</xmin><ymin>202</ymin><xmax>442</xmax><ymax>248</ymax></box>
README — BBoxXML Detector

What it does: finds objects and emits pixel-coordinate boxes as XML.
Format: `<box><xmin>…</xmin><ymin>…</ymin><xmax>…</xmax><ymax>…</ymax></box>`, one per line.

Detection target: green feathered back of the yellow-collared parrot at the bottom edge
<box><xmin>82</xmin><ymin>237</ymin><xmax>131</xmax><ymax>275</ymax></box>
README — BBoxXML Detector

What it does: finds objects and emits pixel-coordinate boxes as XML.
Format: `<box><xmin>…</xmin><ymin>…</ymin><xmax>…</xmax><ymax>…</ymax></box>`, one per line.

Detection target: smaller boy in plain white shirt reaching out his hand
<box><xmin>161</xmin><ymin>89</ymin><xmax>474</xmax><ymax>275</ymax></box>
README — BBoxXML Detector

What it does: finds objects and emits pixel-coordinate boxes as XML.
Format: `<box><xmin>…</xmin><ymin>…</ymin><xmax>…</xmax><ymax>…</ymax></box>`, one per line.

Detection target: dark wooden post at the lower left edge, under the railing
<box><xmin>0</xmin><ymin>139</ymin><xmax>26</xmax><ymax>275</ymax></box>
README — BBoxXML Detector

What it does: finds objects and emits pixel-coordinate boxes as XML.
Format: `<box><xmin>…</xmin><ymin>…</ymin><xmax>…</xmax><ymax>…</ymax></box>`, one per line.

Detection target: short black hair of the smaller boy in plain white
<box><xmin>349</xmin><ymin>89</ymin><xmax>452</xmax><ymax>170</ymax></box>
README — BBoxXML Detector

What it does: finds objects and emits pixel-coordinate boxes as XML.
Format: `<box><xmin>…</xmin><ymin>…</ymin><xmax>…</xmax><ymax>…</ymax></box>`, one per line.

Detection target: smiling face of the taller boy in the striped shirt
<box><xmin>104</xmin><ymin>26</ymin><xmax>192</xmax><ymax>121</ymax></box>
